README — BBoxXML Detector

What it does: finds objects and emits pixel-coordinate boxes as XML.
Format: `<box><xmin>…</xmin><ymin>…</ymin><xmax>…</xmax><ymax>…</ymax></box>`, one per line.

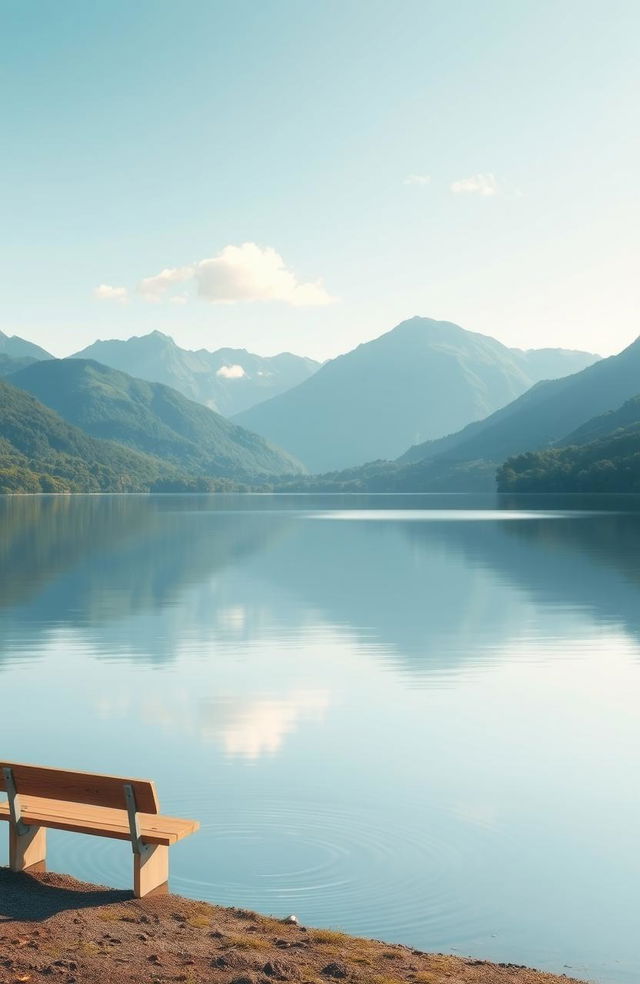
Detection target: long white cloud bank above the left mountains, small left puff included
<box><xmin>94</xmin><ymin>243</ymin><xmax>335</xmax><ymax>307</ymax></box>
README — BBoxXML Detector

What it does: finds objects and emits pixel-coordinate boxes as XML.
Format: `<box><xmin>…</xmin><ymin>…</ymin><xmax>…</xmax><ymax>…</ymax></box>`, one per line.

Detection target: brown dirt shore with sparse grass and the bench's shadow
<box><xmin>0</xmin><ymin>868</ymin><xmax>588</xmax><ymax>984</ymax></box>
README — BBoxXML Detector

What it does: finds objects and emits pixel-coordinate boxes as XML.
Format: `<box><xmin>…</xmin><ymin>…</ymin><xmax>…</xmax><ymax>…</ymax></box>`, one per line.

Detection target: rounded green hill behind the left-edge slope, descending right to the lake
<box><xmin>11</xmin><ymin>359</ymin><xmax>301</xmax><ymax>479</ymax></box>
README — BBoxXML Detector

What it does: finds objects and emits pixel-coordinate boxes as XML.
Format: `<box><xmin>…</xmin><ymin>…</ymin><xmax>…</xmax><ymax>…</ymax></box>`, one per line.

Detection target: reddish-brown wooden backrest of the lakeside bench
<box><xmin>0</xmin><ymin>761</ymin><xmax>160</xmax><ymax>813</ymax></box>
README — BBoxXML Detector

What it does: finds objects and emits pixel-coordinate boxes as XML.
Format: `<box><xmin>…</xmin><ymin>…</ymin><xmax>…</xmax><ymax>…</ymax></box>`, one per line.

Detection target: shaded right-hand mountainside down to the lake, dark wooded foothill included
<box><xmin>272</xmin><ymin>338</ymin><xmax>640</xmax><ymax>492</ymax></box>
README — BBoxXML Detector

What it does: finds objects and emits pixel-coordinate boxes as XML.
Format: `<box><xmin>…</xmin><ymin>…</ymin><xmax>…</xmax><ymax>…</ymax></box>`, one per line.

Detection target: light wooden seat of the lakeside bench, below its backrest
<box><xmin>0</xmin><ymin>796</ymin><xmax>200</xmax><ymax>847</ymax></box>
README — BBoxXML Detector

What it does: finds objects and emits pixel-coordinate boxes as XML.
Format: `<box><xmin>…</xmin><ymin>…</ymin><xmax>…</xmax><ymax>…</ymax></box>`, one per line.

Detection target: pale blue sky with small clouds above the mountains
<box><xmin>0</xmin><ymin>0</ymin><xmax>640</xmax><ymax>358</ymax></box>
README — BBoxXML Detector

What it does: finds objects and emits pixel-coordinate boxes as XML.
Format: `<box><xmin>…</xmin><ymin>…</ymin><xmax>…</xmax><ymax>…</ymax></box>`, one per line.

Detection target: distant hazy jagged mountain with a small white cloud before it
<box><xmin>73</xmin><ymin>331</ymin><xmax>320</xmax><ymax>417</ymax></box>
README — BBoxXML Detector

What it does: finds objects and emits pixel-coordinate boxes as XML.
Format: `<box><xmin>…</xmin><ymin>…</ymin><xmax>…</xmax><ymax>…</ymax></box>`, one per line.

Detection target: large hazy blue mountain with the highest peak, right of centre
<box><xmin>234</xmin><ymin>318</ymin><xmax>597</xmax><ymax>472</ymax></box>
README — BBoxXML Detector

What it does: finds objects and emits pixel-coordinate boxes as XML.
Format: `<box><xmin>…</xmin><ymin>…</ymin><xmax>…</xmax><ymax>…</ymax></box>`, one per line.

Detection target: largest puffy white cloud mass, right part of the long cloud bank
<box><xmin>195</xmin><ymin>243</ymin><xmax>333</xmax><ymax>307</ymax></box>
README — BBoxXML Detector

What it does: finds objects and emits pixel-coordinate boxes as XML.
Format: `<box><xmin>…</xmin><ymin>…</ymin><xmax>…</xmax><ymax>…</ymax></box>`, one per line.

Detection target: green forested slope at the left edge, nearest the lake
<box><xmin>0</xmin><ymin>381</ymin><xmax>176</xmax><ymax>492</ymax></box>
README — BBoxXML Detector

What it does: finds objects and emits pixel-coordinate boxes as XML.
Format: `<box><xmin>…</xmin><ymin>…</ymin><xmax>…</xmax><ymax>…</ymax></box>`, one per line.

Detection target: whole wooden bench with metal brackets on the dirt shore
<box><xmin>0</xmin><ymin>761</ymin><xmax>200</xmax><ymax>898</ymax></box>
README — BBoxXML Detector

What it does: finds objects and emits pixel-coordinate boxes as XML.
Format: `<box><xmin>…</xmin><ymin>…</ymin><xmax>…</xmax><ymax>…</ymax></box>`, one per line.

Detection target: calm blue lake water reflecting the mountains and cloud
<box><xmin>0</xmin><ymin>495</ymin><xmax>640</xmax><ymax>984</ymax></box>
